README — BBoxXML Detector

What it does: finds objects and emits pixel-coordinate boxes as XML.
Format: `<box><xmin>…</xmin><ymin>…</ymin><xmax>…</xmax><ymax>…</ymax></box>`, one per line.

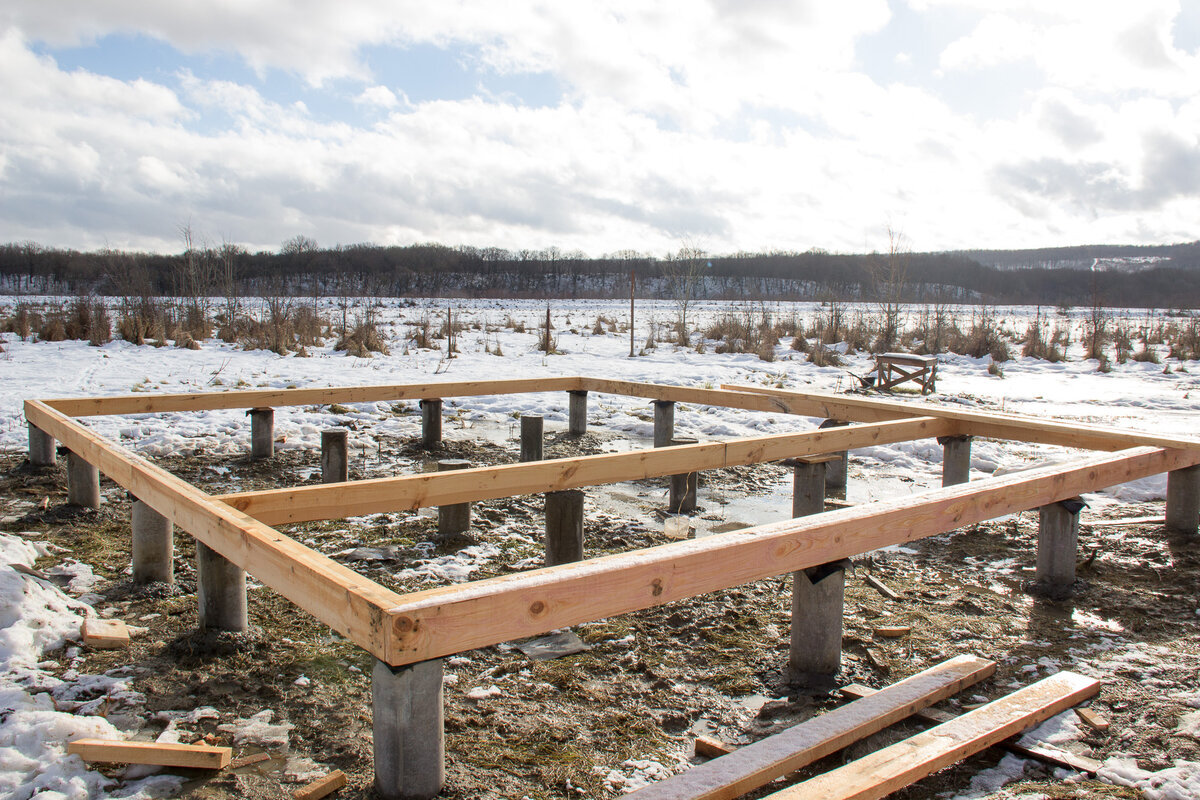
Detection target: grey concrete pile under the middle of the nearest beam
<box><xmin>787</xmin><ymin>561</ymin><xmax>847</xmax><ymax>691</ymax></box>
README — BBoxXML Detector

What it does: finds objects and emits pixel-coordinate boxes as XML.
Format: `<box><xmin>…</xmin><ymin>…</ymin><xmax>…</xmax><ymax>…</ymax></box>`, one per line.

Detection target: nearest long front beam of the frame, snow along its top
<box><xmin>389</xmin><ymin>447</ymin><xmax>1200</xmax><ymax>663</ymax></box>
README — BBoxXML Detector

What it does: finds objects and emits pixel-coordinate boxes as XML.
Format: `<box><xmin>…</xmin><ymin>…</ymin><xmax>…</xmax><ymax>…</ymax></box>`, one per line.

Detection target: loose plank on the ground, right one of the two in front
<box><xmin>768</xmin><ymin>672</ymin><xmax>1100</xmax><ymax>800</ymax></box>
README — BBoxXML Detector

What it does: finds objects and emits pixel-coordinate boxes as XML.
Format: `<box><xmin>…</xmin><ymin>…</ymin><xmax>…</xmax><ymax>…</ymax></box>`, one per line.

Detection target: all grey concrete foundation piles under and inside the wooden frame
<box><xmin>29</xmin><ymin>400</ymin><xmax>1200</xmax><ymax>800</ymax></box>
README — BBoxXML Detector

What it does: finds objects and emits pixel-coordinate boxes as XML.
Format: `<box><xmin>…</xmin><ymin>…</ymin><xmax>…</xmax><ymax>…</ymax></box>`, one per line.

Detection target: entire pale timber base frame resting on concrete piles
<box><xmin>25</xmin><ymin>377</ymin><xmax>1200</xmax><ymax>666</ymax></box>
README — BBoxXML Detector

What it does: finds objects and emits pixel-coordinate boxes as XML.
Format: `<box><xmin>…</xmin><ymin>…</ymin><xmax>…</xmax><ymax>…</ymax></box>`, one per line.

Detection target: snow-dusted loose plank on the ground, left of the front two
<box><xmin>626</xmin><ymin>656</ymin><xmax>996</xmax><ymax>800</ymax></box>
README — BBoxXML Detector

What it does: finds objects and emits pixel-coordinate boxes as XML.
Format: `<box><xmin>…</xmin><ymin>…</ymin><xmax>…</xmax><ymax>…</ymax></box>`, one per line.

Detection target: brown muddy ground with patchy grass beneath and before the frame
<box><xmin>0</xmin><ymin>434</ymin><xmax>1200</xmax><ymax>800</ymax></box>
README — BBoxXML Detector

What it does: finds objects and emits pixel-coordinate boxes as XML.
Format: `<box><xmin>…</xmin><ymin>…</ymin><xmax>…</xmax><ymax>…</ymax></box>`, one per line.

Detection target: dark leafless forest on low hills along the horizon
<box><xmin>0</xmin><ymin>236</ymin><xmax>1200</xmax><ymax>308</ymax></box>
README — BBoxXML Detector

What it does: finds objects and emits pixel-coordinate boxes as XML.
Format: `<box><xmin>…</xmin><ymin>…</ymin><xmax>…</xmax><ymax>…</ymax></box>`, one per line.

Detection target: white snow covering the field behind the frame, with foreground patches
<box><xmin>0</xmin><ymin>297</ymin><xmax>1200</xmax><ymax>800</ymax></box>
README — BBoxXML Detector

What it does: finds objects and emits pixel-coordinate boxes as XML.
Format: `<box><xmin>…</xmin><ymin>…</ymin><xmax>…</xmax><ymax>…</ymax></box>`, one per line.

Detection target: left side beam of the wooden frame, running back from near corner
<box><xmin>25</xmin><ymin>401</ymin><xmax>403</xmax><ymax>658</ymax></box>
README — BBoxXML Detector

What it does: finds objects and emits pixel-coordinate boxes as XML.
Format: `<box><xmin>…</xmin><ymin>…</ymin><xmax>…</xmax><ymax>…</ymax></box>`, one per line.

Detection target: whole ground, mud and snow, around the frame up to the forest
<box><xmin>0</xmin><ymin>297</ymin><xmax>1200</xmax><ymax>798</ymax></box>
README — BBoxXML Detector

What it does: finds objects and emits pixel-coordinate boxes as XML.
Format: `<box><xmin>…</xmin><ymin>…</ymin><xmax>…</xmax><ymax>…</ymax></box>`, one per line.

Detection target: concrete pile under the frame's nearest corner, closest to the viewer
<box><xmin>371</xmin><ymin>658</ymin><xmax>445</xmax><ymax>800</ymax></box>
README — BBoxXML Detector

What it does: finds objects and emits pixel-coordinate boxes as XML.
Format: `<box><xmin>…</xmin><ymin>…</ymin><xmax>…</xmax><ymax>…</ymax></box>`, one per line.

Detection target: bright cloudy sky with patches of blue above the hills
<box><xmin>0</xmin><ymin>0</ymin><xmax>1200</xmax><ymax>255</ymax></box>
